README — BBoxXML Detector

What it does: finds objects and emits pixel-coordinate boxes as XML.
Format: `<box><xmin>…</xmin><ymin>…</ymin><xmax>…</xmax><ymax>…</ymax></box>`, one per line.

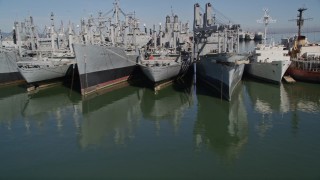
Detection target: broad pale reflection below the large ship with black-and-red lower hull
<box><xmin>79</xmin><ymin>87</ymin><xmax>141</xmax><ymax>148</ymax></box>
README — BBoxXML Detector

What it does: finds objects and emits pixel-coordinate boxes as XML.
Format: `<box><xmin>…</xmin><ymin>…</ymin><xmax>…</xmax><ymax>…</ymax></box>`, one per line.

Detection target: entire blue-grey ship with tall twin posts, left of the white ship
<box><xmin>194</xmin><ymin>3</ymin><xmax>248</xmax><ymax>101</ymax></box>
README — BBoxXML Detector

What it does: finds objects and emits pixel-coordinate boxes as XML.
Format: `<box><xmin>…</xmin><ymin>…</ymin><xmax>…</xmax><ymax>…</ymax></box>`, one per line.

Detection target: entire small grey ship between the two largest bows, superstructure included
<box><xmin>138</xmin><ymin>15</ymin><xmax>191</xmax><ymax>86</ymax></box>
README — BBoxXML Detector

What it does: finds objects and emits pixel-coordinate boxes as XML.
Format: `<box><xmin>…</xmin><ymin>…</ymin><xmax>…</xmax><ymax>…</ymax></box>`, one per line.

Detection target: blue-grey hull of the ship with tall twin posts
<box><xmin>197</xmin><ymin>55</ymin><xmax>244</xmax><ymax>101</ymax></box>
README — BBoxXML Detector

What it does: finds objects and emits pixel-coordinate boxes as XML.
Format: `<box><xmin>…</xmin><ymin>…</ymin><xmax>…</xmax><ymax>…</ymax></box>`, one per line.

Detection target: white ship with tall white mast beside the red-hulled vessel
<box><xmin>245</xmin><ymin>9</ymin><xmax>291</xmax><ymax>83</ymax></box>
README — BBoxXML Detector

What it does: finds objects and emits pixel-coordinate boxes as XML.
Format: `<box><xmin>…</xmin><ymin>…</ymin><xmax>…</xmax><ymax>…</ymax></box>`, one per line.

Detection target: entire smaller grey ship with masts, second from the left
<box><xmin>14</xmin><ymin>13</ymin><xmax>75</xmax><ymax>83</ymax></box>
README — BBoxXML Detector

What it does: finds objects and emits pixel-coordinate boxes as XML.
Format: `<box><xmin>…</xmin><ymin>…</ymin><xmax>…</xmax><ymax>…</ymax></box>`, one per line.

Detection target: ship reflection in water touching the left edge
<box><xmin>0</xmin><ymin>86</ymin><xmax>28</xmax><ymax>130</ymax></box>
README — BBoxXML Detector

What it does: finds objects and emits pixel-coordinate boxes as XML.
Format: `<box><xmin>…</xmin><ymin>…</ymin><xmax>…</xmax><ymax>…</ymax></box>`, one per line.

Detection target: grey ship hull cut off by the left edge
<box><xmin>0</xmin><ymin>50</ymin><xmax>24</xmax><ymax>85</ymax></box>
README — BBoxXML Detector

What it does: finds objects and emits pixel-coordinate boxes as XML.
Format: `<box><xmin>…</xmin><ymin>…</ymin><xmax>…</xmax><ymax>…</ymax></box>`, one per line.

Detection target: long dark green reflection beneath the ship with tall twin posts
<box><xmin>194</xmin><ymin>83</ymin><xmax>248</xmax><ymax>163</ymax></box>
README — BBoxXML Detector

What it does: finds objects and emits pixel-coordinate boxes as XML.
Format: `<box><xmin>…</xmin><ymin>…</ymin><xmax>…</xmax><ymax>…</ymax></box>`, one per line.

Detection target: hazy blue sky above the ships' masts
<box><xmin>0</xmin><ymin>0</ymin><xmax>320</xmax><ymax>32</ymax></box>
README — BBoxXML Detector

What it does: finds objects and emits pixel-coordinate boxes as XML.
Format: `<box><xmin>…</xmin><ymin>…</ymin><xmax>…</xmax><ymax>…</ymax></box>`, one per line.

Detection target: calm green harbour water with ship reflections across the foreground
<box><xmin>0</xmin><ymin>79</ymin><xmax>320</xmax><ymax>179</ymax></box>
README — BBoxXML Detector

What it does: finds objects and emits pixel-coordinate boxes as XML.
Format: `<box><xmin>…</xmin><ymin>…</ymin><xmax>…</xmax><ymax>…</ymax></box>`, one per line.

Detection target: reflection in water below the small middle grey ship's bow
<box><xmin>141</xmin><ymin>82</ymin><xmax>193</xmax><ymax>134</ymax></box>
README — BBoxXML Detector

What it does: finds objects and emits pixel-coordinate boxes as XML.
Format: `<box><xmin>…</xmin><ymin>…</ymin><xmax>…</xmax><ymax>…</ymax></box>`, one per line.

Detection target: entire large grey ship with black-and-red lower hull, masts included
<box><xmin>73</xmin><ymin>1</ymin><xmax>149</xmax><ymax>95</ymax></box>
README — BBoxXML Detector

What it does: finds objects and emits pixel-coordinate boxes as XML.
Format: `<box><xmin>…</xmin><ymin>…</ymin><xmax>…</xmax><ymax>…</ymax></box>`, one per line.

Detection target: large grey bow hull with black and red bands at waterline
<box><xmin>74</xmin><ymin>44</ymin><xmax>136</xmax><ymax>95</ymax></box>
